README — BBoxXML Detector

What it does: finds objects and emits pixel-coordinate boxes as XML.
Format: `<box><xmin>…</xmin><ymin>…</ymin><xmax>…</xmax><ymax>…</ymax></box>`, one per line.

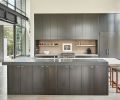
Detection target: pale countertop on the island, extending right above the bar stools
<box><xmin>2</xmin><ymin>57</ymin><xmax>120</xmax><ymax>66</ymax></box>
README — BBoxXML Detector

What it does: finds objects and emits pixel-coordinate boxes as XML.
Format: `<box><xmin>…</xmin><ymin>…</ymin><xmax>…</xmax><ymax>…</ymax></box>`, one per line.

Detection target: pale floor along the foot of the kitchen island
<box><xmin>0</xmin><ymin>87</ymin><xmax>120</xmax><ymax>100</ymax></box>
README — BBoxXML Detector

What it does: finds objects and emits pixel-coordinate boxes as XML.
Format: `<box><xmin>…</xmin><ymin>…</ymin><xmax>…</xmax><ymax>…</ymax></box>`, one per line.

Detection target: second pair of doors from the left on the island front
<box><xmin>33</xmin><ymin>64</ymin><xmax>57</xmax><ymax>95</ymax></box>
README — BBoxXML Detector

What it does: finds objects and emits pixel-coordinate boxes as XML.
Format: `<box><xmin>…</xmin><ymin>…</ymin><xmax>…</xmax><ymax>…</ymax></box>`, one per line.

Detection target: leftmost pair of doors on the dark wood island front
<box><xmin>7</xmin><ymin>64</ymin><xmax>32</xmax><ymax>94</ymax></box>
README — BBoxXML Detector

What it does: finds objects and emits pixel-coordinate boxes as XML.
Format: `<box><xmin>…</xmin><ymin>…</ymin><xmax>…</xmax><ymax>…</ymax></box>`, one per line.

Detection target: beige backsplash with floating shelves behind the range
<box><xmin>36</xmin><ymin>40</ymin><xmax>97</xmax><ymax>54</ymax></box>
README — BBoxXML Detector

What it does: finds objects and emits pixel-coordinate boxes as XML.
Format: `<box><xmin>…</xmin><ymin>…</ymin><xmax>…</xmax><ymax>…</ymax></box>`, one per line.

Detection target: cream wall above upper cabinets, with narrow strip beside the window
<box><xmin>30</xmin><ymin>0</ymin><xmax>120</xmax><ymax>57</ymax></box>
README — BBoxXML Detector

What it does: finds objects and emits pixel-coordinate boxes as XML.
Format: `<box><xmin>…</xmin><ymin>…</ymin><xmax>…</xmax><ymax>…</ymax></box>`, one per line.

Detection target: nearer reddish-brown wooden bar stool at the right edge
<box><xmin>112</xmin><ymin>68</ymin><xmax>120</xmax><ymax>93</ymax></box>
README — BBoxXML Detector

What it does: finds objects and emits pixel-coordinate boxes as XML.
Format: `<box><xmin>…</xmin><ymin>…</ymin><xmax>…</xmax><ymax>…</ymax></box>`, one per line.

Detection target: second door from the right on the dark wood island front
<box><xmin>81</xmin><ymin>64</ymin><xmax>96</xmax><ymax>95</ymax></box>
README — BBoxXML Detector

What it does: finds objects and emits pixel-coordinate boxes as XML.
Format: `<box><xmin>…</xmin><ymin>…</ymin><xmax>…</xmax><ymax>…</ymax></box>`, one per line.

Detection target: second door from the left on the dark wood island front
<box><xmin>21</xmin><ymin>64</ymin><xmax>32</xmax><ymax>94</ymax></box>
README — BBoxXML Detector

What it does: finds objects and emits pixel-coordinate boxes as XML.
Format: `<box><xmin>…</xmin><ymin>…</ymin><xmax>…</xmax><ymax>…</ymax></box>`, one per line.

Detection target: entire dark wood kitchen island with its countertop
<box><xmin>3</xmin><ymin>58</ymin><xmax>108</xmax><ymax>95</ymax></box>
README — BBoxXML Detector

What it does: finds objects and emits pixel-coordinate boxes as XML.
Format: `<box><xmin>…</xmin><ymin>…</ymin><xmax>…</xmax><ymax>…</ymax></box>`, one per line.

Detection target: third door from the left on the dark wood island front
<box><xmin>33</xmin><ymin>65</ymin><xmax>47</xmax><ymax>95</ymax></box>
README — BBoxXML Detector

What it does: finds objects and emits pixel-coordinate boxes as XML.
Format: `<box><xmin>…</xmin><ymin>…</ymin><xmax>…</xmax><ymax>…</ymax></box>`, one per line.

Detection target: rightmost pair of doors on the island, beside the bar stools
<box><xmin>81</xmin><ymin>64</ymin><xmax>108</xmax><ymax>95</ymax></box>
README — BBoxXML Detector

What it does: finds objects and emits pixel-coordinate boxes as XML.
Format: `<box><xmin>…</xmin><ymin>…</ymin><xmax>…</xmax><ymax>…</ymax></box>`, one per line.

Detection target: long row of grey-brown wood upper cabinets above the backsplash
<box><xmin>34</xmin><ymin>14</ymin><xmax>117</xmax><ymax>40</ymax></box>
